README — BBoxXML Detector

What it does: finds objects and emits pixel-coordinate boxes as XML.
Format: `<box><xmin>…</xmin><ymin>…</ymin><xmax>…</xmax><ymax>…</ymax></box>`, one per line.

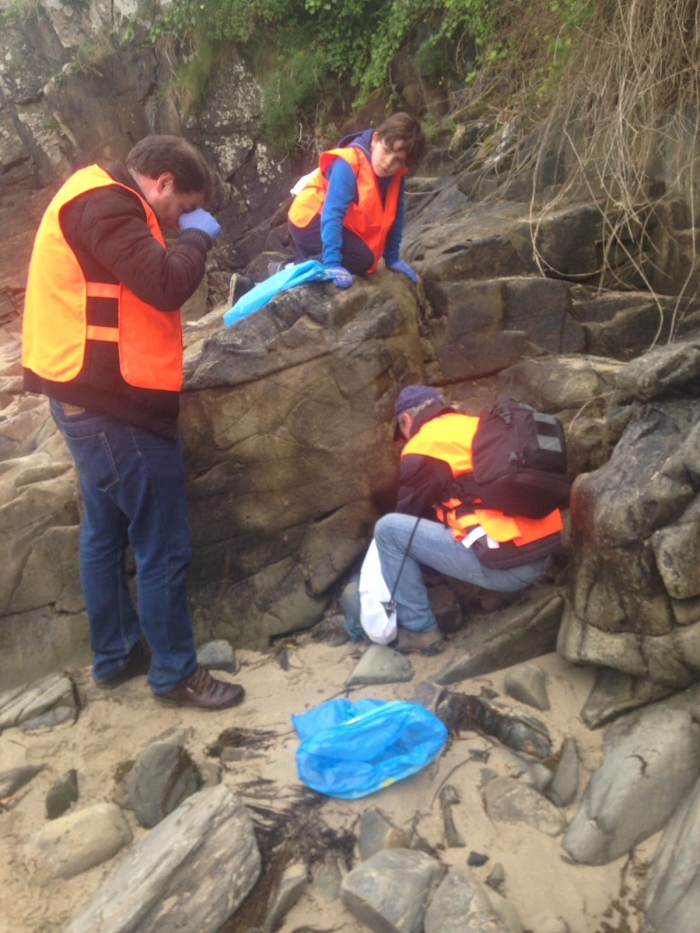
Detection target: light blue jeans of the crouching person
<box><xmin>374</xmin><ymin>512</ymin><xmax>548</xmax><ymax>632</ymax></box>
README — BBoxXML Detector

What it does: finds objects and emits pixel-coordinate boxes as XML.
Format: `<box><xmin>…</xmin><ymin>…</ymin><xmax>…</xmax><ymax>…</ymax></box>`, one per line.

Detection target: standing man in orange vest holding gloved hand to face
<box><xmin>22</xmin><ymin>136</ymin><xmax>244</xmax><ymax>710</ymax></box>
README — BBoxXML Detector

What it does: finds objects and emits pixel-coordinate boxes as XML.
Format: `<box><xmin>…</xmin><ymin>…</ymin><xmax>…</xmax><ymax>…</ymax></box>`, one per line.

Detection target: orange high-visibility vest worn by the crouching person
<box><xmin>401</xmin><ymin>413</ymin><xmax>564</xmax><ymax>547</ymax></box>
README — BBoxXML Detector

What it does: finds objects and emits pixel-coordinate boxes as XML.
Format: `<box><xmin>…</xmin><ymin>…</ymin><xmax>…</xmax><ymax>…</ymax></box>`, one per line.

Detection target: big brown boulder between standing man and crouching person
<box><xmin>182</xmin><ymin>272</ymin><xmax>422</xmax><ymax>644</ymax></box>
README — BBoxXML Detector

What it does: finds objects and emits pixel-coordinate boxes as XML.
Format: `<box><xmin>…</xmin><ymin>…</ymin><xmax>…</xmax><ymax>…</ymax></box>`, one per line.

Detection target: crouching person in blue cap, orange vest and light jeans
<box><xmin>374</xmin><ymin>385</ymin><xmax>562</xmax><ymax>654</ymax></box>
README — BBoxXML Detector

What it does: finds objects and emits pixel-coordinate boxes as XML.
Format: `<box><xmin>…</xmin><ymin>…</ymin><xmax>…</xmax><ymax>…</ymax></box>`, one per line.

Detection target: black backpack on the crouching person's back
<box><xmin>444</xmin><ymin>398</ymin><xmax>571</xmax><ymax>518</ymax></box>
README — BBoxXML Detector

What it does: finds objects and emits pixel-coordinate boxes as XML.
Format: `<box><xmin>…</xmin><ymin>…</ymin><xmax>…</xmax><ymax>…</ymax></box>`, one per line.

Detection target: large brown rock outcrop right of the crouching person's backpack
<box><xmin>557</xmin><ymin>341</ymin><xmax>700</xmax><ymax>689</ymax></box>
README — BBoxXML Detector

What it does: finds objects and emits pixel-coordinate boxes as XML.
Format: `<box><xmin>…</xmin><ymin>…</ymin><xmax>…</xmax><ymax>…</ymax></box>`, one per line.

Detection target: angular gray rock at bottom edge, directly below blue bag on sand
<box><xmin>341</xmin><ymin>849</ymin><xmax>445</xmax><ymax>933</ymax></box>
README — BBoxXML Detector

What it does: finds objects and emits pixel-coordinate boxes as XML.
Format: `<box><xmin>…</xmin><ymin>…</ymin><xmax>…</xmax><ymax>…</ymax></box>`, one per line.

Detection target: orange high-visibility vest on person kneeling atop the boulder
<box><xmin>289</xmin><ymin>146</ymin><xmax>408</xmax><ymax>272</ymax></box>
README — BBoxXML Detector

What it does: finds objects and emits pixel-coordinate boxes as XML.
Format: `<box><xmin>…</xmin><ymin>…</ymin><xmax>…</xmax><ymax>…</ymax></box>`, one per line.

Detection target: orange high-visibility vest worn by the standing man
<box><xmin>22</xmin><ymin>165</ymin><xmax>182</xmax><ymax>392</ymax></box>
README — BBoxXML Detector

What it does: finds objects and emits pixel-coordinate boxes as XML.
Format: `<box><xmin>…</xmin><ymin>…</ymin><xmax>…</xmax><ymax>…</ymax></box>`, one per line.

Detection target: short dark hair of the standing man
<box><xmin>126</xmin><ymin>136</ymin><xmax>214</xmax><ymax>201</ymax></box>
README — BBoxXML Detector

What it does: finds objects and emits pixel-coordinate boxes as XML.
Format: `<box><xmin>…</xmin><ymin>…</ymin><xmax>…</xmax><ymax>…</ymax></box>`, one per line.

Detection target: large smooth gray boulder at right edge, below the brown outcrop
<box><xmin>563</xmin><ymin>700</ymin><xmax>700</xmax><ymax>865</ymax></box>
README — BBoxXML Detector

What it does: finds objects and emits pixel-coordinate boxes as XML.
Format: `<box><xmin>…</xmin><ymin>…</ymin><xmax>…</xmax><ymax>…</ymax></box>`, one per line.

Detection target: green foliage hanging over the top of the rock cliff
<box><xmin>145</xmin><ymin>0</ymin><xmax>594</xmax><ymax>140</ymax></box>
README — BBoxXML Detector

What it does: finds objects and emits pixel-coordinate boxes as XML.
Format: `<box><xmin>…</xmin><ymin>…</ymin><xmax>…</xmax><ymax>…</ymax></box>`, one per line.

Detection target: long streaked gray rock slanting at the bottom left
<box><xmin>66</xmin><ymin>784</ymin><xmax>260</xmax><ymax>933</ymax></box>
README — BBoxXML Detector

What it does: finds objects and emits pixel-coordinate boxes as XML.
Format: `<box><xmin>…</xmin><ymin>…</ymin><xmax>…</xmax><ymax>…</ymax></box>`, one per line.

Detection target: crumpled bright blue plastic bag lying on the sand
<box><xmin>292</xmin><ymin>698</ymin><xmax>447</xmax><ymax>800</ymax></box>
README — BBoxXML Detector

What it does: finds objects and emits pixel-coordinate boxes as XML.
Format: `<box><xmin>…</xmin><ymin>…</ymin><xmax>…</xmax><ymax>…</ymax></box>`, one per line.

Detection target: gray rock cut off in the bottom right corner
<box><xmin>644</xmin><ymin>781</ymin><xmax>700</xmax><ymax>933</ymax></box>
